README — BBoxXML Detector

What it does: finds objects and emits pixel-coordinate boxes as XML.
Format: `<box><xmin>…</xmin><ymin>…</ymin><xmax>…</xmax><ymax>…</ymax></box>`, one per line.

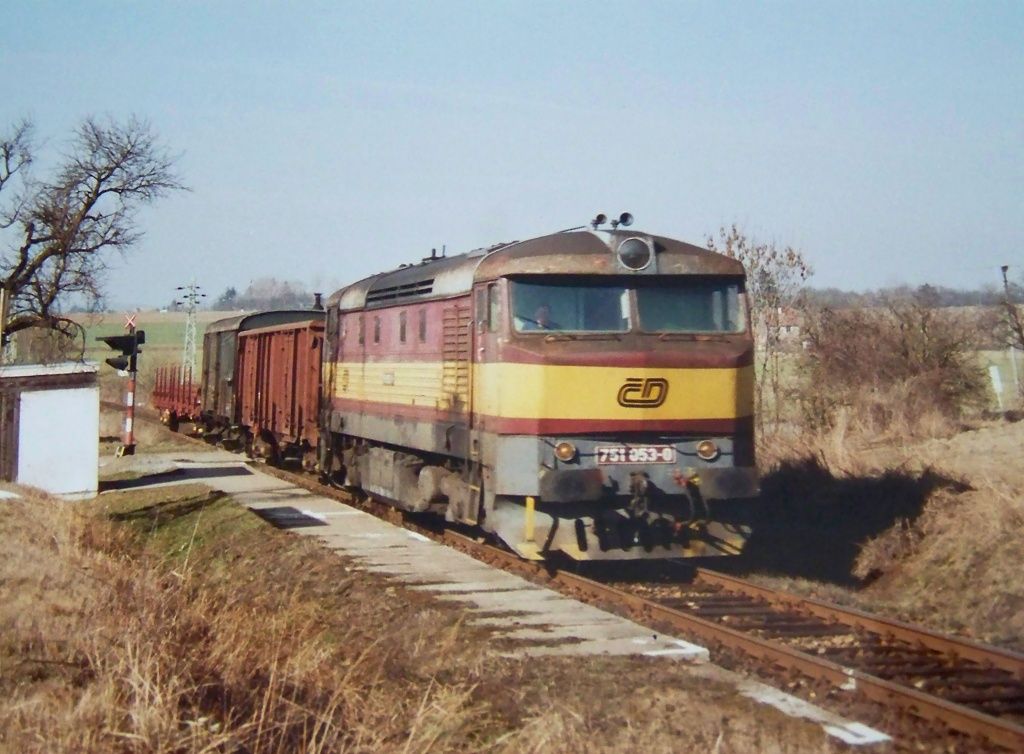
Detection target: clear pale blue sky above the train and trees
<box><xmin>0</xmin><ymin>1</ymin><xmax>1024</xmax><ymax>305</ymax></box>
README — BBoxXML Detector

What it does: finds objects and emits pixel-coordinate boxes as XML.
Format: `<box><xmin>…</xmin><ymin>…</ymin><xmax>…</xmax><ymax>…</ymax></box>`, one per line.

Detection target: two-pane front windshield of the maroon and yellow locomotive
<box><xmin>511</xmin><ymin>277</ymin><xmax>746</xmax><ymax>333</ymax></box>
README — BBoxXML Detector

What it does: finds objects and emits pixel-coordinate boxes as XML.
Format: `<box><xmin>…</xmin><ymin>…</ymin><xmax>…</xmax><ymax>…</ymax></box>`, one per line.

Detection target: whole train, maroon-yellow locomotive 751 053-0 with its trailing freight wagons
<box><xmin>154</xmin><ymin>215</ymin><xmax>758</xmax><ymax>559</ymax></box>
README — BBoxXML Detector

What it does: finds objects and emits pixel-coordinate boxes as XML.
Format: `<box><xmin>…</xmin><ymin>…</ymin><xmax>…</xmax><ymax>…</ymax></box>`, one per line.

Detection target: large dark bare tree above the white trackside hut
<box><xmin>0</xmin><ymin>118</ymin><xmax>184</xmax><ymax>352</ymax></box>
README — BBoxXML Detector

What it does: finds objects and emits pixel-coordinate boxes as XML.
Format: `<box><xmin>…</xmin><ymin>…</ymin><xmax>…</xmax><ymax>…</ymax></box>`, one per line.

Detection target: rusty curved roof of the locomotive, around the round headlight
<box><xmin>328</xmin><ymin>231</ymin><xmax>743</xmax><ymax>310</ymax></box>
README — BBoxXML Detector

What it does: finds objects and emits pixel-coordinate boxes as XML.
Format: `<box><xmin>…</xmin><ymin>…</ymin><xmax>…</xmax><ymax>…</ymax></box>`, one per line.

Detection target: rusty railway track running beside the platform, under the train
<box><xmin>117</xmin><ymin>409</ymin><xmax>1024</xmax><ymax>751</ymax></box>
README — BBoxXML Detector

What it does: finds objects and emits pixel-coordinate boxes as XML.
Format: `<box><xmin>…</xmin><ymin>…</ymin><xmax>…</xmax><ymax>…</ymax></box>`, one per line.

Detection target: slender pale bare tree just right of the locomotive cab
<box><xmin>708</xmin><ymin>223</ymin><xmax>813</xmax><ymax>427</ymax></box>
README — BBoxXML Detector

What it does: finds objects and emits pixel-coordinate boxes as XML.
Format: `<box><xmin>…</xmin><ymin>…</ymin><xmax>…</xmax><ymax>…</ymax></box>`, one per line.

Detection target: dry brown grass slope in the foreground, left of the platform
<box><xmin>0</xmin><ymin>486</ymin><xmax>833</xmax><ymax>752</ymax></box>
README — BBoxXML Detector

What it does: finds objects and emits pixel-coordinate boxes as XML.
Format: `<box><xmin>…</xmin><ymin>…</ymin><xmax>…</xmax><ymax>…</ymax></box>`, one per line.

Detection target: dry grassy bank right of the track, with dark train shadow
<box><xmin>750</xmin><ymin>413</ymin><xmax>1024</xmax><ymax>651</ymax></box>
